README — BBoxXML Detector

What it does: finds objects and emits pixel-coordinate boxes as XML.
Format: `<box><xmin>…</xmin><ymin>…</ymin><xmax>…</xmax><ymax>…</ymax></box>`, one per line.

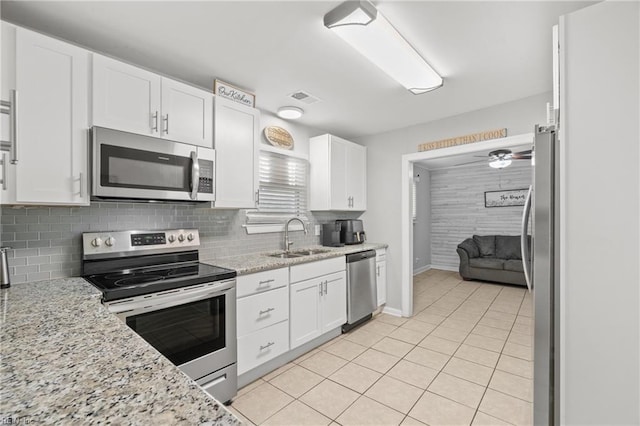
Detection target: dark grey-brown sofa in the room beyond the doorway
<box><xmin>457</xmin><ymin>235</ymin><xmax>531</xmax><ymax>285</ymax></box>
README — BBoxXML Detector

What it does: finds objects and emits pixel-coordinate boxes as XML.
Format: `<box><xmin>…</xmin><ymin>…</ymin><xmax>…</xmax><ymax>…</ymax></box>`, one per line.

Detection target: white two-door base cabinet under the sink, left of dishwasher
<box><xmin>289</xmin><ymin>257</ymin><xmax>347</xmax><ymax>349</ymax></box>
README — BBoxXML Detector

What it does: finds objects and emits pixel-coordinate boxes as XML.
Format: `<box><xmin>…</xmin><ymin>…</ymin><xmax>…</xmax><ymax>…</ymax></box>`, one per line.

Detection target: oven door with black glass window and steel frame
<box><xmin>107</xmin><ymin>279</ymin><xmax>237</xmax><ymax>380</ymax></box>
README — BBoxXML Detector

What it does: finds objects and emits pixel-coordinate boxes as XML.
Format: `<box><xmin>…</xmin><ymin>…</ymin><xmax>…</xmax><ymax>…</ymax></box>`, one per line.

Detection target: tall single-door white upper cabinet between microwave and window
<box><xmin>214</xmin><ymin>96</ymin><xmax>260</xmax><ymax>208</ymax></box>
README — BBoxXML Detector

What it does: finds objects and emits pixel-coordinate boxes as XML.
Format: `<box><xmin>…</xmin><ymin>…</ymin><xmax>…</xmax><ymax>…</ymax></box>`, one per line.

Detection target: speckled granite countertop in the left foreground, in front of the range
<box><xmin>0</xmin><ymin>278</ymin><xmax>240</xmax><ymax>425</ymax></box>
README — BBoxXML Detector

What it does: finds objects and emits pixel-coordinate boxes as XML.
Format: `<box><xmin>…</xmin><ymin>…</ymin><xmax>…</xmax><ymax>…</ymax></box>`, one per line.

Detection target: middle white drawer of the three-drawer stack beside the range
<box><xmin>237</xmin><ymin>287</ymin><xmax>289</xmax><ymax>336</ymax></box>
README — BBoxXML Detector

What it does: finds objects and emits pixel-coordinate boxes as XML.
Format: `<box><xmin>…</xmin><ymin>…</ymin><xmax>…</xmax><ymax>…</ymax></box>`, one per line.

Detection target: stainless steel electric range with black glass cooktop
<box><xmin>82</xmin><ymin>229</ymin><xmax>237</xmax><ymax>402</ymax></box>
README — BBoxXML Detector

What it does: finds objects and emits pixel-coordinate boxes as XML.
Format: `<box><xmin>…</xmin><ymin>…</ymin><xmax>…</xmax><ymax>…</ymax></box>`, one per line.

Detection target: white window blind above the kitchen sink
<box><xmin>247</xmin><ymin>151</ymin><xmax>309</xmax><ymax>224</ymax></box>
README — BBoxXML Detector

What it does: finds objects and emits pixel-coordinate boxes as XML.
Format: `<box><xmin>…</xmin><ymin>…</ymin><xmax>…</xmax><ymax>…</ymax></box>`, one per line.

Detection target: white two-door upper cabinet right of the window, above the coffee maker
<box><xmin>309</xmin><ymin>134</ymin><xmax>367</xmax><ymax>211</ymax></box>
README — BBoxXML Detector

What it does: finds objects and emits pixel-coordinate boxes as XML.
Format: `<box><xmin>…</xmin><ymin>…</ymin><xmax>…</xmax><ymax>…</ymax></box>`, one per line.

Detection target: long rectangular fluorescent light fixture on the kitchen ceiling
<box><xmin>324</xmin><ymin>1</ymin><xmax>443</xmax><ymax>95</ymax></box>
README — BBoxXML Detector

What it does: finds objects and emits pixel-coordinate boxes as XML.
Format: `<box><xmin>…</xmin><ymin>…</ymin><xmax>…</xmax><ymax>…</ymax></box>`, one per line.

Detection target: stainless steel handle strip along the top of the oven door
<box><xmin>108</xmin><ymin>281</ymin><xmax>234</xmax><ymax>316</ymax></box>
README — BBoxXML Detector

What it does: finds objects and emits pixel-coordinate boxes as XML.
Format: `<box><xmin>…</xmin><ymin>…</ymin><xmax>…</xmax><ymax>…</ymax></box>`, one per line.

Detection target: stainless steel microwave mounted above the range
<box><xmin>91</xmin><ymin>127</ymin><xmax>215</xmax><ymax>202</ymax></box>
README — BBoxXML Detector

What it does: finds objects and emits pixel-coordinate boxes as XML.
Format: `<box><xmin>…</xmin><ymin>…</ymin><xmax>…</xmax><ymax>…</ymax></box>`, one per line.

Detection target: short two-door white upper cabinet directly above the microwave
<box><xmin>92</xmin><ymin>54</ymin><xmax>213</xmax><ymax>148</ymax></box>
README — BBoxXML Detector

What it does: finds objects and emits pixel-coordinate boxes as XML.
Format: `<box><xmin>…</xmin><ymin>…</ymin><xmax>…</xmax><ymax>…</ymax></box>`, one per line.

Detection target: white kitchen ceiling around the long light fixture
<box><xmin>2</xmin><ymin>0</ymin><xmax>592</xmax><ymax>138</ymax></box>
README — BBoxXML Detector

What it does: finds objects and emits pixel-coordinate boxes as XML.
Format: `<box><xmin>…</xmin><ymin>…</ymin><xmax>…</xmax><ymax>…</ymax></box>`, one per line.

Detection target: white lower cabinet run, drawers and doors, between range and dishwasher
<box><xmin>236</xmin><ymin>256</ymin><xmax>347</xmax><ymax>375</ymax></box>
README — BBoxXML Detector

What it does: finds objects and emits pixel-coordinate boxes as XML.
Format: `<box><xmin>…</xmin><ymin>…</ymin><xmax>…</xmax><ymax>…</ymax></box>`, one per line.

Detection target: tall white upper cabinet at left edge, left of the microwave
<box><xmin>2</xmin><ymin>23</ymin><xmax>89</xmax><ymax>205</ymax></box>
